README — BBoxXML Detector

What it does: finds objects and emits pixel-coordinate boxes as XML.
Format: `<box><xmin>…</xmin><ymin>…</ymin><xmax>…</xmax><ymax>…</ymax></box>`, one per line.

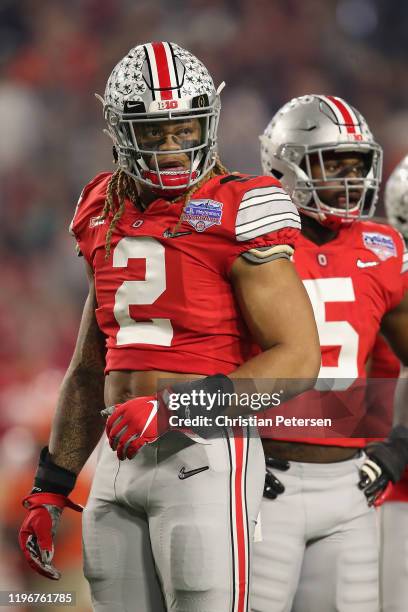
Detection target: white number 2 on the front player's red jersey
<box><xmin>113</xmin><ymin>236</ymin><xmax>173</xmax><ymax>346</ymax></box>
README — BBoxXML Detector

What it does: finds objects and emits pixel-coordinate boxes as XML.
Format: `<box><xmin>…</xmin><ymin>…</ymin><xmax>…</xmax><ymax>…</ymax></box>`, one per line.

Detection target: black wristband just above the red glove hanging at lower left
<box><xmin>31</xmin><ymin>446</ymin><xmax>77</xmax><ymax>497</ymax></box>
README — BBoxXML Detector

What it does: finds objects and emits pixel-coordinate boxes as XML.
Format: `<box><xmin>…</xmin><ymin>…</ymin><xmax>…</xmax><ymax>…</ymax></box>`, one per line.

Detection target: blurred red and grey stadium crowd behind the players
<box><xmin>0</xmin><ymin>0</ymin><xmax>408</xmax><ymax>612</ymax></box>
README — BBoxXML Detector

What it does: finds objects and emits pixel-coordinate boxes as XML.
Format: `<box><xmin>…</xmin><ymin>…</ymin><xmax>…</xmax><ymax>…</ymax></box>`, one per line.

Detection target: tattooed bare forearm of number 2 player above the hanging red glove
<box><xmin>49</xmin><ymin>364</ymin><xmax>105</xmax><ymax>474</ymax></box>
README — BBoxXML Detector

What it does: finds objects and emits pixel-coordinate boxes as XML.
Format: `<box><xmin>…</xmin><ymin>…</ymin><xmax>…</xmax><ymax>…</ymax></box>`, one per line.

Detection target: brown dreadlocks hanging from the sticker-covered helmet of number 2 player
<box><xmin>101</xmin><ymin>155</ymin><xmax>230</xmax><ymax>259</ymax></box>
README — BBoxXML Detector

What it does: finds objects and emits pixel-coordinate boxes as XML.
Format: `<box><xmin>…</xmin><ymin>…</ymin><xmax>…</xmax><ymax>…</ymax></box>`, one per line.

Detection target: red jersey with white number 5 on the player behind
<box><xmin>261</xmin><ymin>221</ymin><xmax>404</xmax><ymax>447</ymax></box>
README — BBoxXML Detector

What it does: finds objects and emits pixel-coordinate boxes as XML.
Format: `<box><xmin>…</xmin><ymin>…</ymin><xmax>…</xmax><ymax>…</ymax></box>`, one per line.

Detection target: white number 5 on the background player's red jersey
<box><xmin>303</xmin><ymin>278</ymin><xmax>358</xmax><ymax>391</ymax></box>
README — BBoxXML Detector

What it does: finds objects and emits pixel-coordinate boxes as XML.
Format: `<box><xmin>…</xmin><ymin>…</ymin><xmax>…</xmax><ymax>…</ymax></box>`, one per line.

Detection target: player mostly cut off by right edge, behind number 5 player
<box><xmin>370</xmin><ymin>156</ymin><xmax>408</xmax><ymax>612</ymax></box>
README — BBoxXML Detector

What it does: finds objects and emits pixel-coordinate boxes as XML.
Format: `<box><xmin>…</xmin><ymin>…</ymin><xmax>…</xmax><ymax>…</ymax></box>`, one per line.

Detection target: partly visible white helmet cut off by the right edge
<box><xmin>384</xmin><ymin>155</ymin><xmax>408</xmax><ymax>243</ymax></box>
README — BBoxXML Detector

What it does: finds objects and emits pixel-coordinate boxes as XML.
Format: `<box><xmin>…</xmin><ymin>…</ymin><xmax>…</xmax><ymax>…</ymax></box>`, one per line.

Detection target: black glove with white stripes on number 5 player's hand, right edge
<box><xmin>358</xmin><ymin>425</ymin><xmax>408</xmax><ymax>506</ymax></box>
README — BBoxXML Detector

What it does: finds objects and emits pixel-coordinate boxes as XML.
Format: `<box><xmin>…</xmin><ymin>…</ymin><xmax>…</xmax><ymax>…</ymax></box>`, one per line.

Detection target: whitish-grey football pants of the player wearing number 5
<box><xmin>252</xmin><ymin>456</ymin><xmax>379</xmax><ymax>612</ymax></box>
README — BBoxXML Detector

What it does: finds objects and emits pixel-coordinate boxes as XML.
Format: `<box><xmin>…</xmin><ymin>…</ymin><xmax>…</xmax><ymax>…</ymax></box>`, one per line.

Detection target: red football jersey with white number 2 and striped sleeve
<box><xmin>71</xmin><ymin>173</ymin><xmax>300</xmax><ymax>375</ymax></box>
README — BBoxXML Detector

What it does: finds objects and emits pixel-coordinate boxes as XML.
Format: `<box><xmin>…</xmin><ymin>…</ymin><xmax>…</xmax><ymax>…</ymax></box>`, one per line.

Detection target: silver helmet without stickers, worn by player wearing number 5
<box><xmin>260</xmin><ymin>95</ymin><xmax>382</xmax><ymax>229</ymax></box>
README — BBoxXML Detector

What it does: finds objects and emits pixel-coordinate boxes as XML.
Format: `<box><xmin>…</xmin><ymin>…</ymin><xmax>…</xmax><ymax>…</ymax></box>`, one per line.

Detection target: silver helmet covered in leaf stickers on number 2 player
<box><xmin>102</xmin><ymin>42</ymin><xmax>224</xmax><ymax>195</ymax></box>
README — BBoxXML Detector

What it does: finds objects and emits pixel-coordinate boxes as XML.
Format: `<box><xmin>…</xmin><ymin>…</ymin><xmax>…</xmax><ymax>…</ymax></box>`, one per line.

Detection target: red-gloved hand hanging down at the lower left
<box><xmin>18</xmin><ymin>493</ymin><xmax>83</xmax><ymax>580</ymax></box>
